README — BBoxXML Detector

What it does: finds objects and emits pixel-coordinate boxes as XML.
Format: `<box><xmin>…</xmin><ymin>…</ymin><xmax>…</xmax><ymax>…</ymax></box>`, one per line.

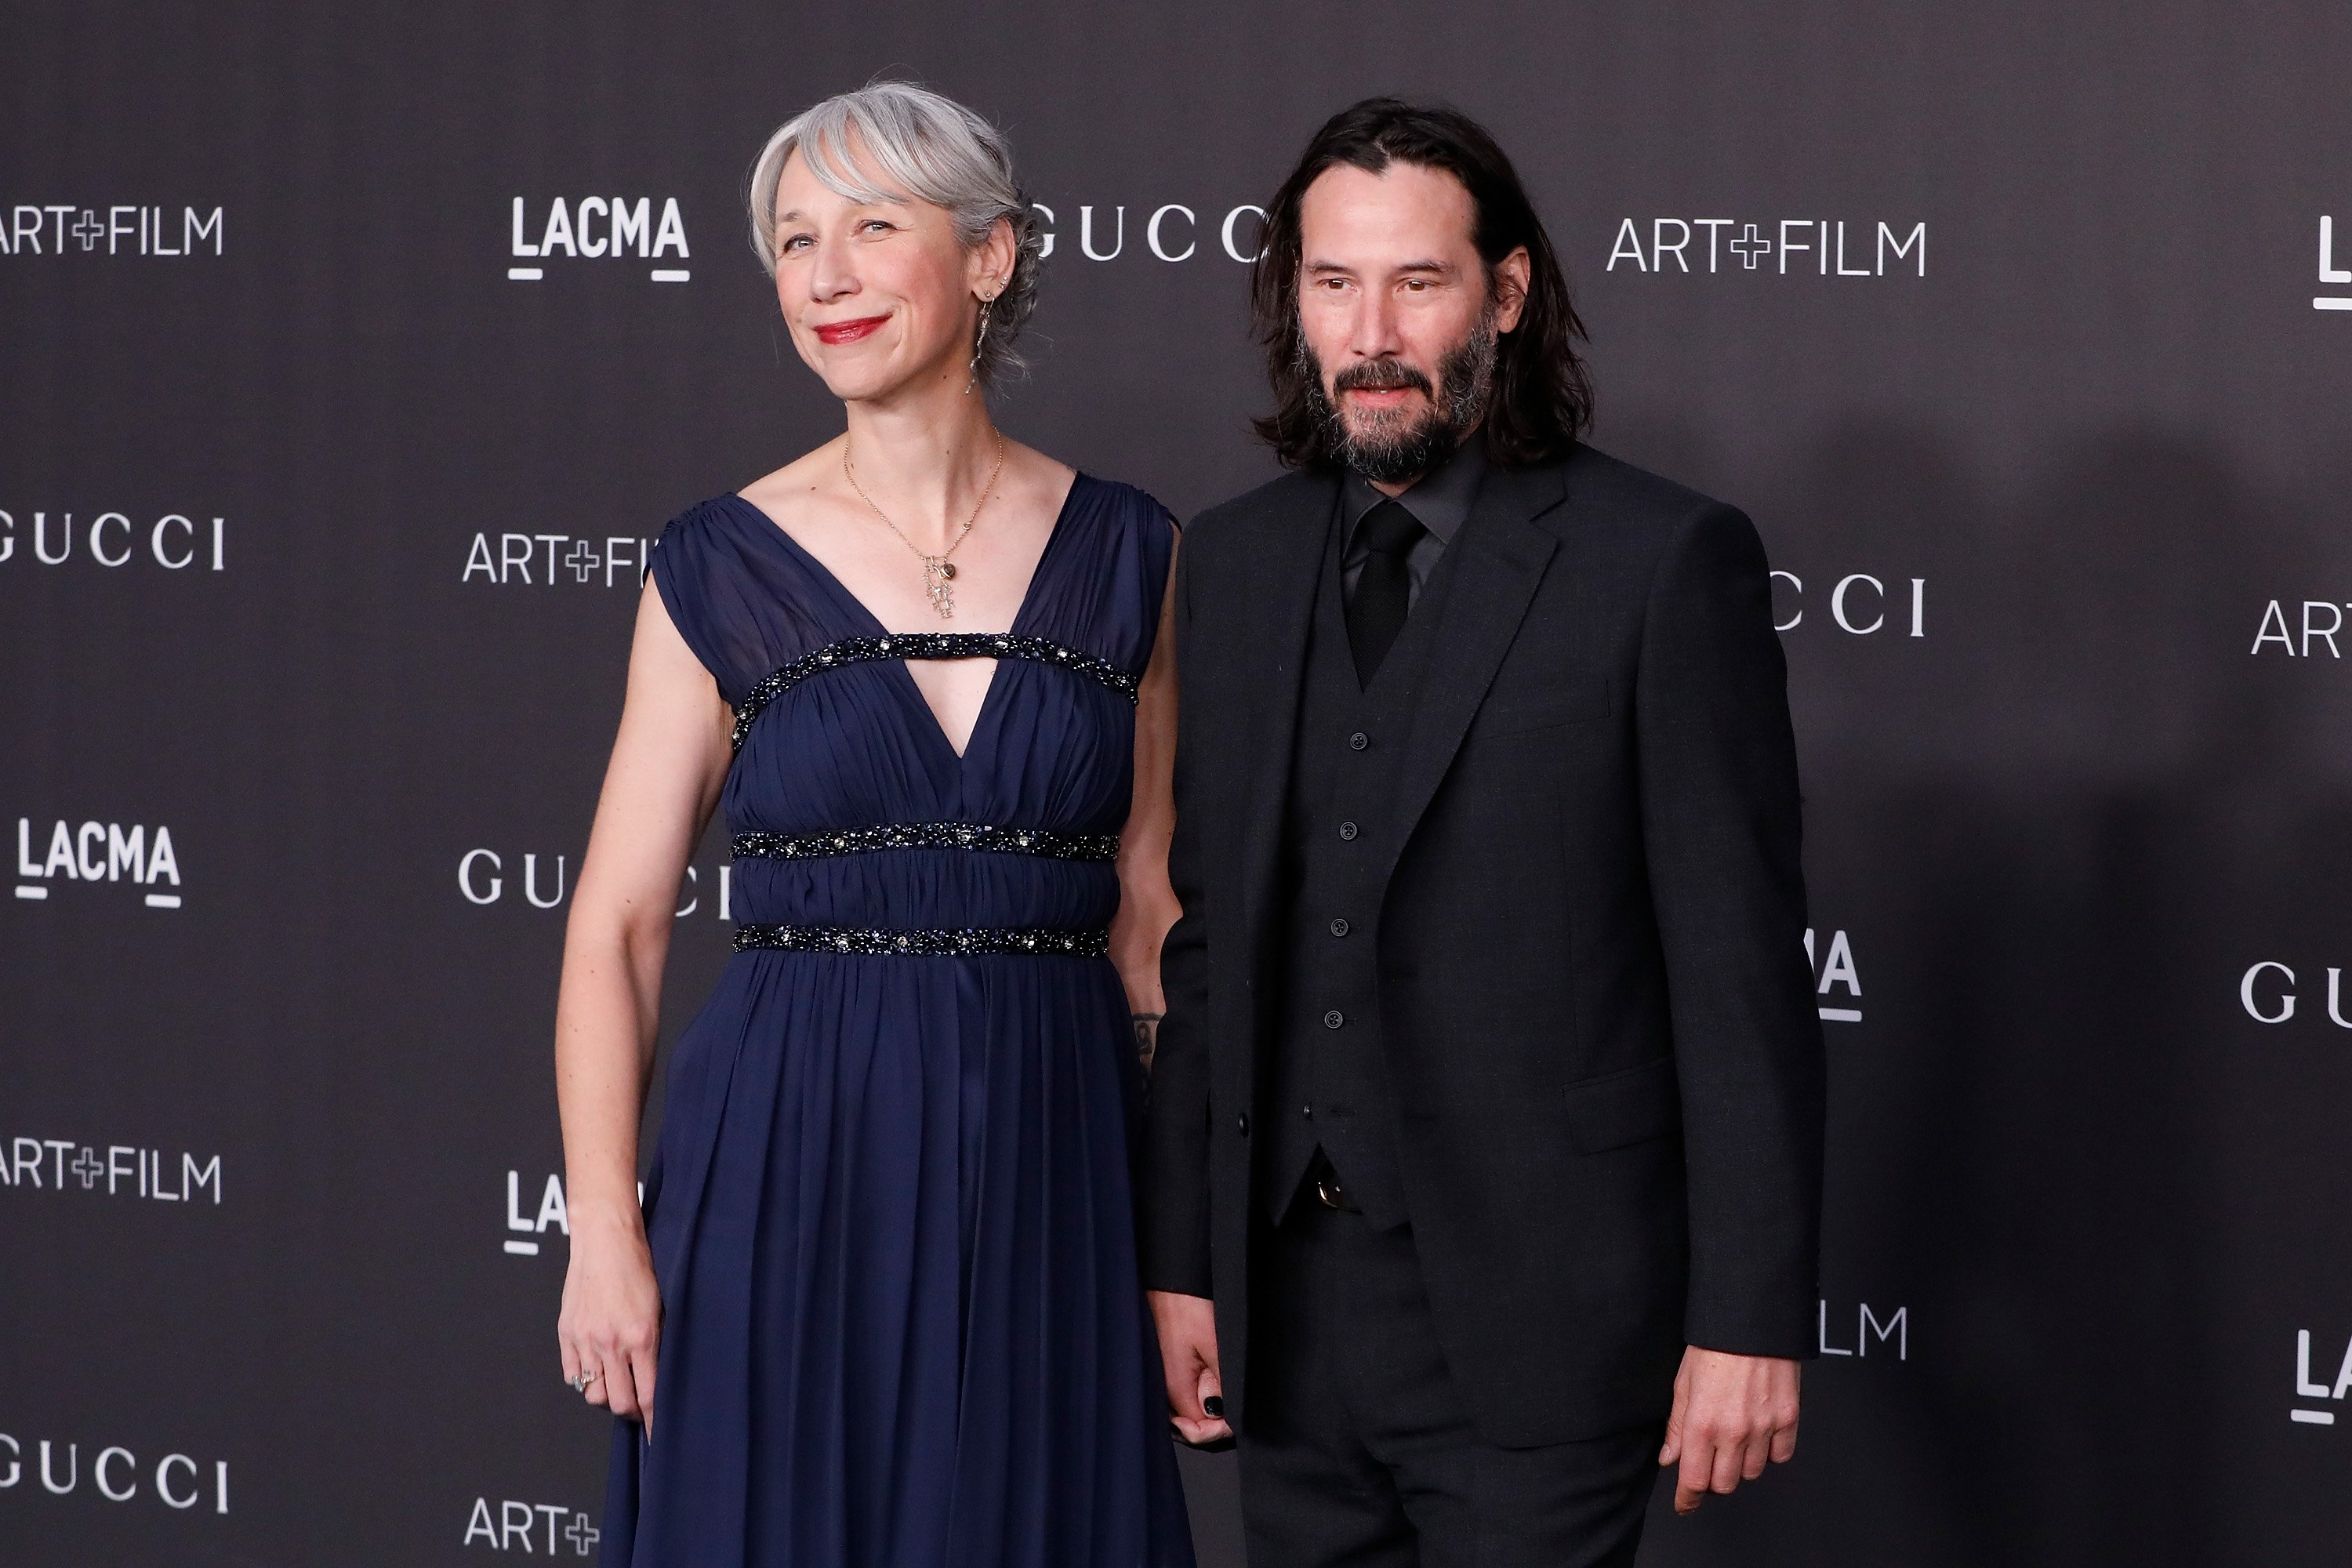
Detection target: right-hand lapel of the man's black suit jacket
<box><xmin>1381</xmin><ymin>468</ymin><xmax>1566</xmax><ymax>884</ymax></box>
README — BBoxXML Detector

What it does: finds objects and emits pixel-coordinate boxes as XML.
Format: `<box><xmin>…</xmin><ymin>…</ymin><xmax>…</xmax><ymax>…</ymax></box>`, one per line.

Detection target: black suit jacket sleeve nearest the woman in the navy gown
<box><xmin>1138</xmin><ymin>526</ymin><xmax>1214</xmax><ymax>1295</ymax></box>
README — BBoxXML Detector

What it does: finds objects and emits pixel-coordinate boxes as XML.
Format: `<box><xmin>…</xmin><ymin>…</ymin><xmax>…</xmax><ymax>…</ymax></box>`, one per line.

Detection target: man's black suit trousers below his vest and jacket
<box><xmin>1240</xmin><ymin>1185</ymin><xmax>1665</xmax><ymax>1568</ymax></box>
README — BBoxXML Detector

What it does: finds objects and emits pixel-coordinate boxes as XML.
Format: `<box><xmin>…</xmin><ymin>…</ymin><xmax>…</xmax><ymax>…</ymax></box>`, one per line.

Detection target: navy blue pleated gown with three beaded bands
<box><xmin>602</xmin><ymin>475</ymin><xmax>1192</xmax><ymax>1568</ymax></box>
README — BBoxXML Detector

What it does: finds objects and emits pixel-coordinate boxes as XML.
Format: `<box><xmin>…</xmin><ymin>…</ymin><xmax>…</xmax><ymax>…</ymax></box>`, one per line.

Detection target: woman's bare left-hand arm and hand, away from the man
<box><xmin>555</xmin><ymin>583</ymin><xmax>729</xmax><ymax>1434</ymax></box>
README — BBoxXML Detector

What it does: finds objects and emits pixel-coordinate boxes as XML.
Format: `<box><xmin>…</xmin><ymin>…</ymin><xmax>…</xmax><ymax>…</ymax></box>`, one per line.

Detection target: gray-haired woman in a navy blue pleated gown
<box><xmin>555</xmin><ymin>82</ymin><xmax>1192</xmax><ymax>1568</ymax></box>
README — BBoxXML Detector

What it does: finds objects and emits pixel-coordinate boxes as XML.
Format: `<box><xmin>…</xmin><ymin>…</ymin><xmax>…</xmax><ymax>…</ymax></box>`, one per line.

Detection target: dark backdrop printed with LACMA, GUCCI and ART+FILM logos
<box><xmin>0</xmin><ymin>0</ymin><xmax>2352</xmax><ymax>1568</ymax></box>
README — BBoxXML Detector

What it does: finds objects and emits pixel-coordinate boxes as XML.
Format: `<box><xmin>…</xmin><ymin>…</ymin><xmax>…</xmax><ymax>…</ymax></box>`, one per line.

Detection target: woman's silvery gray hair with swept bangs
<box><xmin>750</xmin><ymin>82</ymin><xmax>1042</xmax><ymax>386</ymax></box>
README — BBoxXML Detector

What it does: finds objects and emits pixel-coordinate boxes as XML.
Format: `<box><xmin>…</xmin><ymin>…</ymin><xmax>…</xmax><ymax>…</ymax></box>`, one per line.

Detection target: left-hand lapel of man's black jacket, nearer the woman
<box><xmin>1242</xmin><ymin>475</ymin><xmax>1338</xmax><ymax>964</ymax></box>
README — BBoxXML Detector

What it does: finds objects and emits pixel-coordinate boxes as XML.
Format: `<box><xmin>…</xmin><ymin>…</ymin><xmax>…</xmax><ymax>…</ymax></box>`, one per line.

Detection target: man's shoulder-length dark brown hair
<box><xmin>1249</xmin><ymin>99</ymin><xmax>1592</xmax><ymax>468</ymax></box>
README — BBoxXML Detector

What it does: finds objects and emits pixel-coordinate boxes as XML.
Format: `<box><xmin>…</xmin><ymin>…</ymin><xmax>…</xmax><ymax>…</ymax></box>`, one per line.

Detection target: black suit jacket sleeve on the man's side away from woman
<box><xmin>1635</xmin><ymin>503</ymin><xmax>1825</xmax><ymax>1356</ymax></box>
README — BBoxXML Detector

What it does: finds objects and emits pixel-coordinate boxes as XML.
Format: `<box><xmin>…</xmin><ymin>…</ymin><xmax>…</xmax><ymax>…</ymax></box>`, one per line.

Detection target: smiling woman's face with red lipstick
<box><xmin>776</xmin><ymin>148</ymin><xmax>1011</xmax><ymax>402</ymax></box>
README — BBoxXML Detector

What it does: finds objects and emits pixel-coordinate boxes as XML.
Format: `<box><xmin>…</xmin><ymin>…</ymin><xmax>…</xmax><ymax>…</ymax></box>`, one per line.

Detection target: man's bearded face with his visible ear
<box><xmin>1298</xmin><ymin>162</ymin><xmax>1529</xmax><ymax>487</ymax></box>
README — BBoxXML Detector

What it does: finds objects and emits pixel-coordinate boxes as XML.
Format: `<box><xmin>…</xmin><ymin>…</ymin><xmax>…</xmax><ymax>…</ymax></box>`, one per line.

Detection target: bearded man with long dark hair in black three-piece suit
<box><xmin>1143</xmin><ymin>99</ymin><xmax>1823</xmax><ymax>1568</ymax></box>
